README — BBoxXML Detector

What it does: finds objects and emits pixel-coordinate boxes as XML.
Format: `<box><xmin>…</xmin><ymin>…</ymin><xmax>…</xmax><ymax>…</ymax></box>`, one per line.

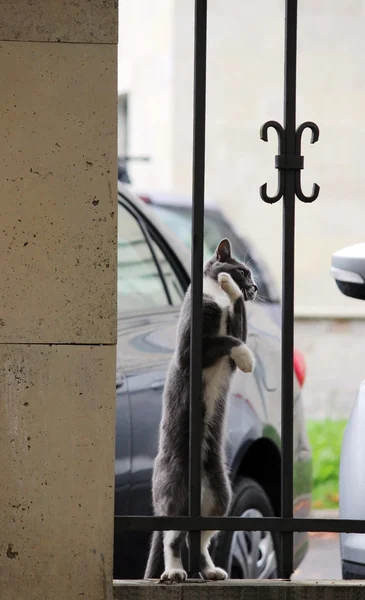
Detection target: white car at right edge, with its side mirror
<box><xmin>331</xmin><ymin>243</ymin><xmax>365</xmax><ymax>579</ymax></box>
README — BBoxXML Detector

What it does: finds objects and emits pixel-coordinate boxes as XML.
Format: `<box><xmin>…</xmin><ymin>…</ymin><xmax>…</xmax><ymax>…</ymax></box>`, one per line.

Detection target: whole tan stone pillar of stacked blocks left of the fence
<box><xmin>0</xmin><ymin>0</ymin><xmax>117</xmax><ymax>600</ymax></box>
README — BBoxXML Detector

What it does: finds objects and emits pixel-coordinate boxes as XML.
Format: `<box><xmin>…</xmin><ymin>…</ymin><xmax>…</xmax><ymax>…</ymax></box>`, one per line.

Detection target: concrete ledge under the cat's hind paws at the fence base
<box><xmin>114</xmin><ymin>579</ymin><xmax>365</xmax><ymax>600</ymax></box>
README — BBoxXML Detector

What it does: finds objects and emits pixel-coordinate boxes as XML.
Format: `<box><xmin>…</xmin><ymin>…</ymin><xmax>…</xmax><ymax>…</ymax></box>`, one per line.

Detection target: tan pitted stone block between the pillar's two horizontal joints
<box><xmin>0</xmin><ymin>42</ymin><xmax>117</xmax><ymax>344</ymax></box>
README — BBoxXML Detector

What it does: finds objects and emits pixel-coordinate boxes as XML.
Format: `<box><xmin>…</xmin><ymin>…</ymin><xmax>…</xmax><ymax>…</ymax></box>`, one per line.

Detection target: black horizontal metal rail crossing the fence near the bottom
<box><xmin>114</xmin><ymin>515</ymin><xmax>365</xmax><ymax>533</ymax></box>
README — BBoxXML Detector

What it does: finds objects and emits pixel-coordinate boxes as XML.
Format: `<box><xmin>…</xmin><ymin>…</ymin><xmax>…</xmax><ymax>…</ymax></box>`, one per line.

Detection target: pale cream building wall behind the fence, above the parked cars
<box><xmin>119</xmin><ymin>0</ymin><xmax>365</xmax><ymax>316</ymax></box>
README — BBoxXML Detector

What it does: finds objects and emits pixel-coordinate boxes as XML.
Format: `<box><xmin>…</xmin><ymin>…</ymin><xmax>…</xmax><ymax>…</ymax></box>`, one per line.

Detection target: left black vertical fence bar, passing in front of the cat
<box><xmin>189</xmin><ymin>0</ymin><xmax>207</xmax><ymax>578</ymax></box>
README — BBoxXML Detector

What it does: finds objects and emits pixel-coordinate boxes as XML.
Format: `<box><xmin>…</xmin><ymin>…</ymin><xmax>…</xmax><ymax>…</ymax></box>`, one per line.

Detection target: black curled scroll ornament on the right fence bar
<box><xmin>260</xmin><ymin>121</ymin><xmax>320</xmax><ymax>204</ymax></box>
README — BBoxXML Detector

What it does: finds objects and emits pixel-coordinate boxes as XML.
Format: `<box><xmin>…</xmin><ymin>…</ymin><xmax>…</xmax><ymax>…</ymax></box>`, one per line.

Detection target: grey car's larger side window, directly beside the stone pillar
<box><xmin>118</xmin><ymin>204</ymin><xmax>170</xmax><ymax>313</ymax></box>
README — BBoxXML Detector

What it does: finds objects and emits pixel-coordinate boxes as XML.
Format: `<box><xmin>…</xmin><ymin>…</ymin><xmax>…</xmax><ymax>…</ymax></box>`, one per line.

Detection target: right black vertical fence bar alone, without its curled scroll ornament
<box><xmin>280</xmin><ymin>0</ymin><xmax>298</xmax><ymax>579</ymax></box>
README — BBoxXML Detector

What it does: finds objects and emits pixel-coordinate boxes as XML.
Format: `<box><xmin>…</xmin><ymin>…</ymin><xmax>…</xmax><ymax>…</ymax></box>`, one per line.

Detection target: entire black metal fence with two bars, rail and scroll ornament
<box><xmin>115</xmin><ymin>0</ymin><xmax>365</xmax><ymax>579</ymax></box>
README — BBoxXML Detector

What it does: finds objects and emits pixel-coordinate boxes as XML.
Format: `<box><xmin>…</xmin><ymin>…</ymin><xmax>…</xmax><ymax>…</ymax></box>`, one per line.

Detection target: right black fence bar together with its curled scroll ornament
<box><xmin>260</xmin><ymin>0</ymin><xmax>319</xmax><ymax>579</ymax></box>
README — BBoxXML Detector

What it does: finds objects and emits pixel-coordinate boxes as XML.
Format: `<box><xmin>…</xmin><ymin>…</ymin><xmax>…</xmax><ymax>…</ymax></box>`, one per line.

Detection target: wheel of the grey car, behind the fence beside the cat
<box><xmin>216</xmin><ymin>477</ymin><xmax>278</xmax><ymax>579</ymax></box>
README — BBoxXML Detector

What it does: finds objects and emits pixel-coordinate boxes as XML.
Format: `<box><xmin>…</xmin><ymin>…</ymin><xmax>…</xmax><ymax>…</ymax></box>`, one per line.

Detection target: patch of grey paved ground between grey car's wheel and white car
<box><xmin>292</xmin><ymin>533</ymin><xmax>342</xmax><ymax>581</ymax></box>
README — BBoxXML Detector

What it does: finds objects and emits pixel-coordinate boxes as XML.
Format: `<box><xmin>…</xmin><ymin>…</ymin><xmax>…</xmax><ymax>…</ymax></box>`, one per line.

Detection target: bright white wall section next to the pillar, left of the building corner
<box><xmin>118</xmin><ymin>0</ymin><xmax>174</xmax><ymax>189</ymax></box>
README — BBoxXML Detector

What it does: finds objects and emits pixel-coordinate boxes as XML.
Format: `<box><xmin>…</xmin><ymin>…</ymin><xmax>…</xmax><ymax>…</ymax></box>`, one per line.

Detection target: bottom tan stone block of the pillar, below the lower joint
<box><xmin>0</xmin><ymin>344</ymin><xmax>115</xmax><ymax>600</ymax></box>
